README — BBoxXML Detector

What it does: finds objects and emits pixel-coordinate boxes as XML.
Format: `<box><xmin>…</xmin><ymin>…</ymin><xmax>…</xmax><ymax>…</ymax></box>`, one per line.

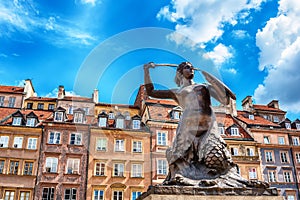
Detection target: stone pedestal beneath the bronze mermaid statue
<box><xmin>137</xmin><ymin>186</ymin><xmax>284</xmax><ymax>200</ymax></box>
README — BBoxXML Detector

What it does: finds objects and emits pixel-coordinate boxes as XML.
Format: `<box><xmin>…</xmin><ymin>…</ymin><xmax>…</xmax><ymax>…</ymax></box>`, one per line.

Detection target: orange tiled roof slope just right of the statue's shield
<box><xmin>237</xmin><ymin>111</ymin><xmax>280</xmax><ymax>127</ymax></box>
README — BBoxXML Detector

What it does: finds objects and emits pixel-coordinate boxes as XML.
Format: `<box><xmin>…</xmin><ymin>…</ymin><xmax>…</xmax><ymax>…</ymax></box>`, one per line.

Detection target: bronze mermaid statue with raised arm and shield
<box><xmin>144</xmin><ymin>62</ymin><xmax>268</xmax><ymax>188</ymax></box>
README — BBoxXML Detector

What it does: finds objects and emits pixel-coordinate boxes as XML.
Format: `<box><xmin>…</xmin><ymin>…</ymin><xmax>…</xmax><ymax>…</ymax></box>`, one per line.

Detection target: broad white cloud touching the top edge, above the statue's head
<box><xmin>157</xmin><ymin>0</ymin><xmax>265</xmax><ymax>43</ymax></box>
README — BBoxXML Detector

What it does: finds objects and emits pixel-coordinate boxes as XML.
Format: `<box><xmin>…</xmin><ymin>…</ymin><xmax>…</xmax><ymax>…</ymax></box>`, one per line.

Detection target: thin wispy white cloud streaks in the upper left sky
<box><xmin>0</xmin><ymin>0</ymin><xmax>96</xmax><ymax>46</ymax></box>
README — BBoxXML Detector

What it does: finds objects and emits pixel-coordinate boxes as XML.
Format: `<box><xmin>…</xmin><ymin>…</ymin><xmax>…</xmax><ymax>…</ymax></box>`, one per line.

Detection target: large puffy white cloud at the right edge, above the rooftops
<box><xmin>254</xmin><ymin>0</ymin><xmax>300</xmax><ymax>113</ymax></box>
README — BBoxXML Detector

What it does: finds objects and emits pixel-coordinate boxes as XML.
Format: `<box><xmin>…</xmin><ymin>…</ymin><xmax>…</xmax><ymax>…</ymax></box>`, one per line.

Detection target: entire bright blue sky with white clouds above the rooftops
<box><xmin>0</xmin><ymin>0</ymin><xmax>300</xmax><ymax>120</ymax></box>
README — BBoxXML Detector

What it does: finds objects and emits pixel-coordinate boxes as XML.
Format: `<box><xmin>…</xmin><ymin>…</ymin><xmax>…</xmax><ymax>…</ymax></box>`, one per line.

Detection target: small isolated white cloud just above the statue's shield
<box><xmin>203</xmin><ymin>44</ymin><xmax>233</xmax><ymax>67</ymax></box>
